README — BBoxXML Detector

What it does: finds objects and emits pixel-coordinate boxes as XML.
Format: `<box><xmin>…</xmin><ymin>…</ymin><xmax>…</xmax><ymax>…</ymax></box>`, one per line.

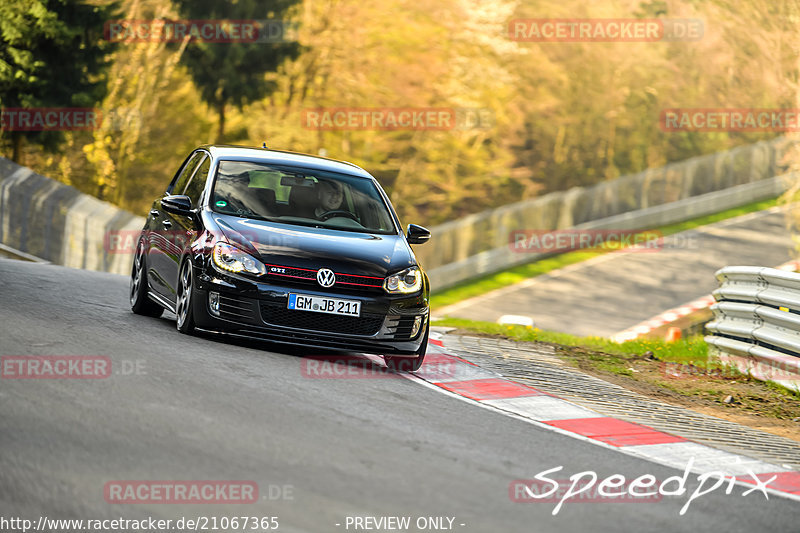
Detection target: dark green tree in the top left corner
<box><xmin>0</xmin><ymin>0</ymin><xmax>117</xmax><ymax>162</ymax></box>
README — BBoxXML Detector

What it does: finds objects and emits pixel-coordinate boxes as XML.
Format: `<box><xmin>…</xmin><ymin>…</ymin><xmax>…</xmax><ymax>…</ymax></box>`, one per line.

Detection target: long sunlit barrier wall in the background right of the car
<box><xmin>415</xmin><ymin>138</ymin><xmax>790</xmax><ymax>276</ymax></box>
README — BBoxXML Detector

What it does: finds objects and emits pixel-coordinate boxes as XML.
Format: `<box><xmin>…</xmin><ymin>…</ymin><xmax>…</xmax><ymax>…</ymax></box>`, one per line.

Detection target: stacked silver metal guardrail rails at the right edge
<box><xmin>705</xmin><ymin>266</ymin><xmax>800</xmax><ymax>392</ymax></box>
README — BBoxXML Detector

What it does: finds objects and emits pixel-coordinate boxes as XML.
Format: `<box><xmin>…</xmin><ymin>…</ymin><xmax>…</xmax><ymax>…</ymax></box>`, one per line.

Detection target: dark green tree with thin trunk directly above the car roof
<box><xmin>175</xmin><ymin>0</ymin><xmax>300</xmax><ymax>142</ymax></box>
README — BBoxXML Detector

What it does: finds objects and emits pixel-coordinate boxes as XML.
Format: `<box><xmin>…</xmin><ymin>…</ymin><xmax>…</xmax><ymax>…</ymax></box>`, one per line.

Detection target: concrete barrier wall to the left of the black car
<box><xmin>0</xmin><ymin>158</ymin><xmax>144</xmax><ymax>274</ymax></box>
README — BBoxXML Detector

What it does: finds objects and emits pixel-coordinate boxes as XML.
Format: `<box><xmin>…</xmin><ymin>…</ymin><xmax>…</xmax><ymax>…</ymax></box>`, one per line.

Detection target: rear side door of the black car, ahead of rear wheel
<box><xmin>147</xmin><ymin>150</ymin><xmax>206</xmax><ymax>302</ymax></box>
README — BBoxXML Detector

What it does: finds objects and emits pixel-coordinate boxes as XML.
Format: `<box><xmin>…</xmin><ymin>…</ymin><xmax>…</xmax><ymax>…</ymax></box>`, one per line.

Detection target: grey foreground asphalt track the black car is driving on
<box><xmin>0</xmin><ymin>259</ymin><xmax>800</xmax><ymax>533</ymax></box>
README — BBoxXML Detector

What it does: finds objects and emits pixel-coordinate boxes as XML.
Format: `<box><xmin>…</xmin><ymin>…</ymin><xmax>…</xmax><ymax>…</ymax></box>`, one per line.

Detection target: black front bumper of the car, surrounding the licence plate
<box><xmin>192</xmin><ymin>269</ymin><xmax>428</xmax><ymax>355</ymax></box>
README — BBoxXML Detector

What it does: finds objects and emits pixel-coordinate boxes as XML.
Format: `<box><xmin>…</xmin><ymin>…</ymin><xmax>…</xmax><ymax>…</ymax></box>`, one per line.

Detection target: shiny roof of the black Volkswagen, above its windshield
<box><xmin>199</xmin><ymin>144</ymin><xmax>375</xmax><ymax>179</ymax></box>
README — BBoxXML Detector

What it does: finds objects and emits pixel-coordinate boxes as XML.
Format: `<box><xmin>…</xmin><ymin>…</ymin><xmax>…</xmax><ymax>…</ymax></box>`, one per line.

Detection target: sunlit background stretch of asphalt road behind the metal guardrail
<box><xmin>434</xmin><ymin>209</ymin><xmax>793</xmax><ymax>337</ymax></box>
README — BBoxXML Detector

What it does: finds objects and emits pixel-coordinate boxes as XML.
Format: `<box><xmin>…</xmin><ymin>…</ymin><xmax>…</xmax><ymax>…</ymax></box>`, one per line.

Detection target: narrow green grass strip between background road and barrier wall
<box><xmin>431</xmin><ymin>195</ymin><xmax>778</xmax><ymax>310</ymax></box>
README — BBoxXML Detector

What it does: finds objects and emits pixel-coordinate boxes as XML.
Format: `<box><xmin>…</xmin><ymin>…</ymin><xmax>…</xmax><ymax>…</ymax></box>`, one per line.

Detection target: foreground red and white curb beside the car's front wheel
<box><xmin>403</xmin><ymin>332</ymin><xmax>800</xmax><ymax>501</ymax></box>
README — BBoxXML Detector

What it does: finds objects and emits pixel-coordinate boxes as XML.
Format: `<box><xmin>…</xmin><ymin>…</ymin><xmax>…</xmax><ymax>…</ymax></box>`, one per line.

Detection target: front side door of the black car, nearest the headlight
<box><xmin>162</xmin><ymin>154</ymin><xmax>211</xmax><ymax>301</ymax></box>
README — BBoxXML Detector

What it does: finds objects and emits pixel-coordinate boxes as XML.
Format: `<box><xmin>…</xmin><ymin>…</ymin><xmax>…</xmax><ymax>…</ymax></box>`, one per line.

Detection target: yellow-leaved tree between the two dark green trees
<box><xmin>81</xmin><ymin>0</ymin><xmax>198</xmax><ymax>204</ymax></box>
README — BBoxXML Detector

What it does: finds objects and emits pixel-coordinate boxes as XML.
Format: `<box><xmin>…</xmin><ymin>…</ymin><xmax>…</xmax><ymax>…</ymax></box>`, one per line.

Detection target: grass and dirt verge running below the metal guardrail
<box><xmin>433</xmin><ymin>318</ymin><xmax>800</xmax><ymax>428</ymax></box>
